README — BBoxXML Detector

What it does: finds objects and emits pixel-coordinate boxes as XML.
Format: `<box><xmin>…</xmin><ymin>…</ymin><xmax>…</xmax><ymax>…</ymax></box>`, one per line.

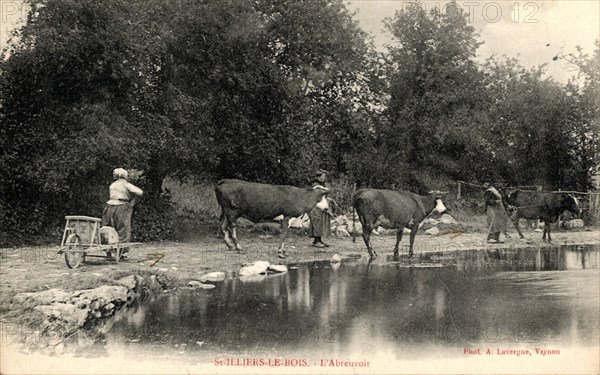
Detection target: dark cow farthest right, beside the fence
<box><xmin>506</xmin><ymin>190</ymin><xmax>580</xmax><ymax>242</ymax></box>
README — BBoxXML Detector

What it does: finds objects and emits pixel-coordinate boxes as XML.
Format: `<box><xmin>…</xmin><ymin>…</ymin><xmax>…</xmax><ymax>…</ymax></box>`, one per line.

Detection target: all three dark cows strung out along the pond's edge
<box><xmin>215</xmin><ymin>179</ymin><xmax>580</xmax><ymax>257</ymax></box>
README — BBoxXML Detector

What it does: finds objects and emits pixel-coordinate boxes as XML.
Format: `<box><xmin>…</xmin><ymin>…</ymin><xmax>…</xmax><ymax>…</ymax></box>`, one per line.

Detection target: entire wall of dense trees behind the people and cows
<box><xmin>0</xmin><ymin>0</ymin><xmax>600</xmax><ymax>243</ymax></box>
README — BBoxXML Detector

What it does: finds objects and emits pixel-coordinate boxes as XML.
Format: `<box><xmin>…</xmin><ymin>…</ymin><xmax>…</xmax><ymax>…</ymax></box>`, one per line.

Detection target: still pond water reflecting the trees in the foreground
<box><xmin>86</xmin><ymin>246</ymin><xmax>600</xmax><ymax>362</ymax></box>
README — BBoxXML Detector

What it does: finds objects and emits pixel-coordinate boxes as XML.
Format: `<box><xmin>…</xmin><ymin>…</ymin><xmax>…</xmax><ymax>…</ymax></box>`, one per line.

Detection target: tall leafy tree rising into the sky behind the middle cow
<box><xmin>380</xmin><ymin>2</ymin><xmax>487</xmax><ymax>190</ymax></box>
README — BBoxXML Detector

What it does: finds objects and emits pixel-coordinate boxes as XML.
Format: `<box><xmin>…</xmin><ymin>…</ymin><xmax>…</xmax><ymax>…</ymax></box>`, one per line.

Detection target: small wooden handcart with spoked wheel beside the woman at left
<box><xmin>58</xmin><ymin>216</ymin><xmax>142</xmax><ymax>268</ymax></box>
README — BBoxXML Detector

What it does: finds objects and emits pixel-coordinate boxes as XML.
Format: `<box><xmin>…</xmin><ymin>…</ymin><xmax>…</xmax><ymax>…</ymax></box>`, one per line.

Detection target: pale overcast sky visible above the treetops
<box><xmin>0</xmin><ymin>0</ymin><xmax>600</xmax><ymax>82</ymax></box>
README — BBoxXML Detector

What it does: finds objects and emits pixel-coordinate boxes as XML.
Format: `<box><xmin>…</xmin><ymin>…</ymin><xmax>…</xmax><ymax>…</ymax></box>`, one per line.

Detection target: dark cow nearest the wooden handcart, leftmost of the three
<box><xmin>215</xmin><ymin>180</ymin><xmax>329</xmax><ymax>255</ymax></box>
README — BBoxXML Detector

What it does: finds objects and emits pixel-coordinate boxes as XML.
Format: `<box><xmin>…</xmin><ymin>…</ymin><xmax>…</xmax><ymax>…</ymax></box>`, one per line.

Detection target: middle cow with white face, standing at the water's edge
<box><xmin>354</xmin><ymin>189</ymin><xmax>446</xmax><ymax>258</ymax></box>
